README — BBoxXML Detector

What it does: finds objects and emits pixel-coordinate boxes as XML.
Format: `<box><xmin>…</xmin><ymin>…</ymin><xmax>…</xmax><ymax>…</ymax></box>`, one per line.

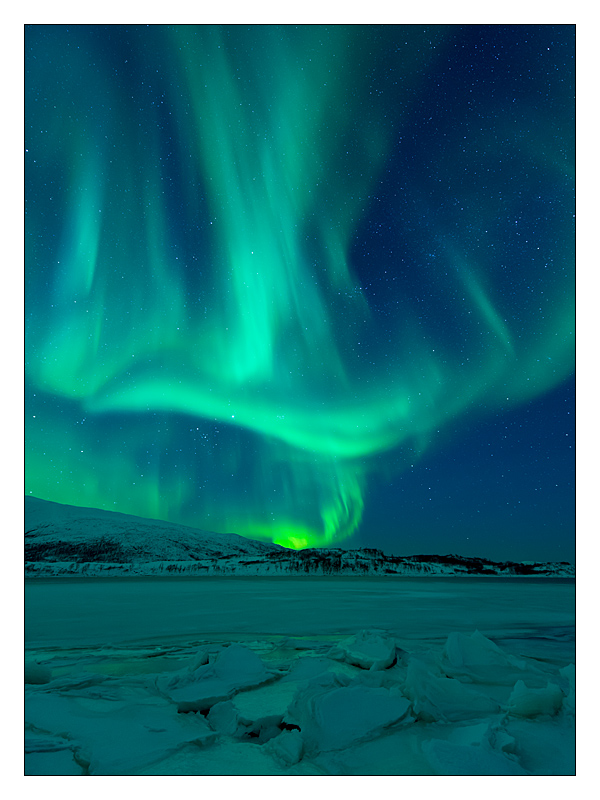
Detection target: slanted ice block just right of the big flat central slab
<box><xmin>404</xmin><ymin>658</ymin><xmax>500</xmax><ymax>722</ymax></box>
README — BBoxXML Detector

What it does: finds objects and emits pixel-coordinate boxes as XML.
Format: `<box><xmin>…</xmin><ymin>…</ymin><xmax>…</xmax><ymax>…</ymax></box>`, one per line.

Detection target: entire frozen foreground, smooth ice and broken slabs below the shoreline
<box><xmin>25</xmin><ymin>577</ymin><xmax>575</xmax><ymax>775</ymax></box>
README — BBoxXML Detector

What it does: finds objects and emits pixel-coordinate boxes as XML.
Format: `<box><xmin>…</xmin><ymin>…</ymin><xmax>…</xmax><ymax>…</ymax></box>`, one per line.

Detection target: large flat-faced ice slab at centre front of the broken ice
<box><xmin>289</xmin><ymin>673</ymin><xmax>412</xmax><ymax>752</ymax></box>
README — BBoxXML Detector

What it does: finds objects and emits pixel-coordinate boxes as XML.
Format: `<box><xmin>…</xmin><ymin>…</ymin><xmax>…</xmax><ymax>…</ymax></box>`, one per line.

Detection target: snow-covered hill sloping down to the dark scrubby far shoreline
<box><xmin>25</xmin><ymin>497</ymin><xmax>575</xmax><ymax>577</ymax></box>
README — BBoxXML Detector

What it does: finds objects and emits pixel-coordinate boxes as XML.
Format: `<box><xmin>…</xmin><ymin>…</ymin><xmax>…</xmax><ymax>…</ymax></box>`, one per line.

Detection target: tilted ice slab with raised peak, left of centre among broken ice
<box><xmin>156</xmin><ymin>644</ymin><xmax>273</xmax><ymax>711</ymax></box>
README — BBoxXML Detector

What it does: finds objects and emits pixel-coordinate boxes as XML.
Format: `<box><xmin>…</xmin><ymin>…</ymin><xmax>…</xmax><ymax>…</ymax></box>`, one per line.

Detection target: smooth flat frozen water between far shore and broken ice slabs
<box><xmin>25</xmin><ymin>577</ymin><xmax>575</xmax><ymax>661</ymax></box>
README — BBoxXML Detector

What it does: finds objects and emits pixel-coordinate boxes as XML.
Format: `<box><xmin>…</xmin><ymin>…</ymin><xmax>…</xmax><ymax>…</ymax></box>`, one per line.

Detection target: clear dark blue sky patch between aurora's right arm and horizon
<box><xmin>356</xmin><ymin>381</ymin><xmax>575</xmax><ymax>563</ymax></box>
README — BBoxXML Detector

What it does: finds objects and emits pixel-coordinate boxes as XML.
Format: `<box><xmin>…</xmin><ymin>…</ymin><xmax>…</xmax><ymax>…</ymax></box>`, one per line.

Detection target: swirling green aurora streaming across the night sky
<box><xmin>26</xmin><ymin>26</ymin><xmax>574</xmax><ymax>548</ymax></box>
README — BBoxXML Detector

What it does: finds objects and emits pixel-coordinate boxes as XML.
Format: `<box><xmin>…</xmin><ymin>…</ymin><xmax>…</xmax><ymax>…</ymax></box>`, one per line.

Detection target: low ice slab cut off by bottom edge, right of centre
<box><xmin>423</xmin><ymin>739</ymin><xmax>529</xmax><ymax>775</ymax></box>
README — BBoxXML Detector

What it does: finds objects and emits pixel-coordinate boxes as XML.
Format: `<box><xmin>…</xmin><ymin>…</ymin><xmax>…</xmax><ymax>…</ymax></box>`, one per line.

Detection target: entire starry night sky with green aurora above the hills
<box><xmin>25</xmin><ymin>25</ymin><xmax>575</xmax><ymax>561</ymax></box>
